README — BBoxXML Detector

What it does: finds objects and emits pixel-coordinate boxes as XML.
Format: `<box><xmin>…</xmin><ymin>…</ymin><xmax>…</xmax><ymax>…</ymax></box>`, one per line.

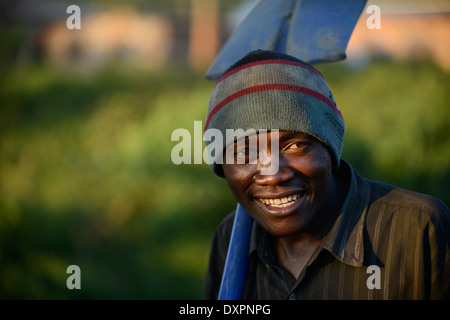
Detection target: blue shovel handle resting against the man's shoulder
<box><xmin>219</xmin><ymin>203</ymin><xmax>253</xmax><ymax>300</ymax></box>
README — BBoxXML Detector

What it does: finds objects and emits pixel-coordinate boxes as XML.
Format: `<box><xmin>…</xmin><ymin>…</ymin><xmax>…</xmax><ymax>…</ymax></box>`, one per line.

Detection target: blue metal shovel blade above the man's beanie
<box><xmin>205</xmin><ymin>0</ymin><xmax>367</xmax><ymax>80</ymax></box>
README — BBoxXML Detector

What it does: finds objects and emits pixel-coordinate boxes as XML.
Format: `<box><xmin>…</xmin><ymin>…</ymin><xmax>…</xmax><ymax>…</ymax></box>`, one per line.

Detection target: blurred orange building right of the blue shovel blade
<box><xmin>347</xmin><ymin>1</ymin><xmax>450</xmax><ymax>71</ymax></box>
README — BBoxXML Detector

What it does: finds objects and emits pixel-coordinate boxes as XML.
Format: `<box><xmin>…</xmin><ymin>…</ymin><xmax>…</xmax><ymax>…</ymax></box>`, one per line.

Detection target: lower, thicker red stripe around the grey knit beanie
<box><xmin>204</xmin><ymin>84</ymin><xmax>344</xmax><ymax>131</ymax></box>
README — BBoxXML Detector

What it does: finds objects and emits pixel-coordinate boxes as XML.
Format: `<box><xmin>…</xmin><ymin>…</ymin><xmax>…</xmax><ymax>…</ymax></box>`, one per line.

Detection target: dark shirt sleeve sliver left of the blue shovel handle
<box><xmin>203</xmin><ymin>211</ymin><xmax>235</xmax><ymax>300</ymax></box>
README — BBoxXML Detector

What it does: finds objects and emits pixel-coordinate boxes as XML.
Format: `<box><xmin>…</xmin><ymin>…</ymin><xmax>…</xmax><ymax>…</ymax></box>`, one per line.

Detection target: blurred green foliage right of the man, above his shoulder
<box><xmin>319</xmin><ymin>61</ymin><xmax>450</xmax><ymax>200</ymax></box>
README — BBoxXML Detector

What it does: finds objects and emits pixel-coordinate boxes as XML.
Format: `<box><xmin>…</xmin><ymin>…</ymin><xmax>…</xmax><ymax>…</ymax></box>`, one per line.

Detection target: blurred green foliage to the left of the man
<box><xmin>0</xmin><ymin>68</ymin><xmax>234</xmax><ymax>299</ymax></box>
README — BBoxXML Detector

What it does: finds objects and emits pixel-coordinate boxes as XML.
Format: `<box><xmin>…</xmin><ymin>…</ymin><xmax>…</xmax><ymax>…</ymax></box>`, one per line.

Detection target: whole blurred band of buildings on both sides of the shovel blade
<box><xmin>0</xmin><ymin>0</ymin><xmax>450</xmax><ymax>71</ymax></box>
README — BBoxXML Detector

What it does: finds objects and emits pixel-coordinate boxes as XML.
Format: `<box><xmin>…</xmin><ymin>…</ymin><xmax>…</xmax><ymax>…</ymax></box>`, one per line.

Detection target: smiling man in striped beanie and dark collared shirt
<box><xmin>205</xmin><ymin>50</ymin><xmax>450</xmax><ymax>299</ymax></box>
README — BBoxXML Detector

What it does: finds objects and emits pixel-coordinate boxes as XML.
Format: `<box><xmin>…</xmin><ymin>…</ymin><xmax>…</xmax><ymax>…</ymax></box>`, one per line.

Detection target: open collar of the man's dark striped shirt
<box><xmin>249</xmin><ymin>159</ymin><xmax>370</xmax><ymax>266</ymax></box>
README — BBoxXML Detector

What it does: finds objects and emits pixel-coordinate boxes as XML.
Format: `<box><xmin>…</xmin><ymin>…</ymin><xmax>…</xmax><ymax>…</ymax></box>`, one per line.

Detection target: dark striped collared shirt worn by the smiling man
<box><xmin>204</xmin><ymin>160</ymin><xmax>450</xmax><ymax>299</ymax></box>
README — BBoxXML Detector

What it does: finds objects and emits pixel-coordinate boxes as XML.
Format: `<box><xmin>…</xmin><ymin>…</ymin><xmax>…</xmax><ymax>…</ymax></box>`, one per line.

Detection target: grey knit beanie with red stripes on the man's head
<box><xmin>204</xmin><ymin>50</ymin><xmax>345</xmax><ymax>177</ymax></box>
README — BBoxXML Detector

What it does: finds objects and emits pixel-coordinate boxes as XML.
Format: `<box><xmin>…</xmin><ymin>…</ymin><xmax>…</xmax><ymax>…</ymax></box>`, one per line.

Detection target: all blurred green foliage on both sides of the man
<box><xmin>0</xmin><ymin>58</ymin><xmax>450</xmax><ymax>299</ymax></box>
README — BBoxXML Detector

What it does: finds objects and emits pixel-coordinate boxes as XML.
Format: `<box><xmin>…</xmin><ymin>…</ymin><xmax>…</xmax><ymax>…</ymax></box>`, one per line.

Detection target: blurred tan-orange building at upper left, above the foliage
<box><xmin>37</xmin><ymin>8</ymin><xmax>174</xmax><ymax>66</ymax></box>
